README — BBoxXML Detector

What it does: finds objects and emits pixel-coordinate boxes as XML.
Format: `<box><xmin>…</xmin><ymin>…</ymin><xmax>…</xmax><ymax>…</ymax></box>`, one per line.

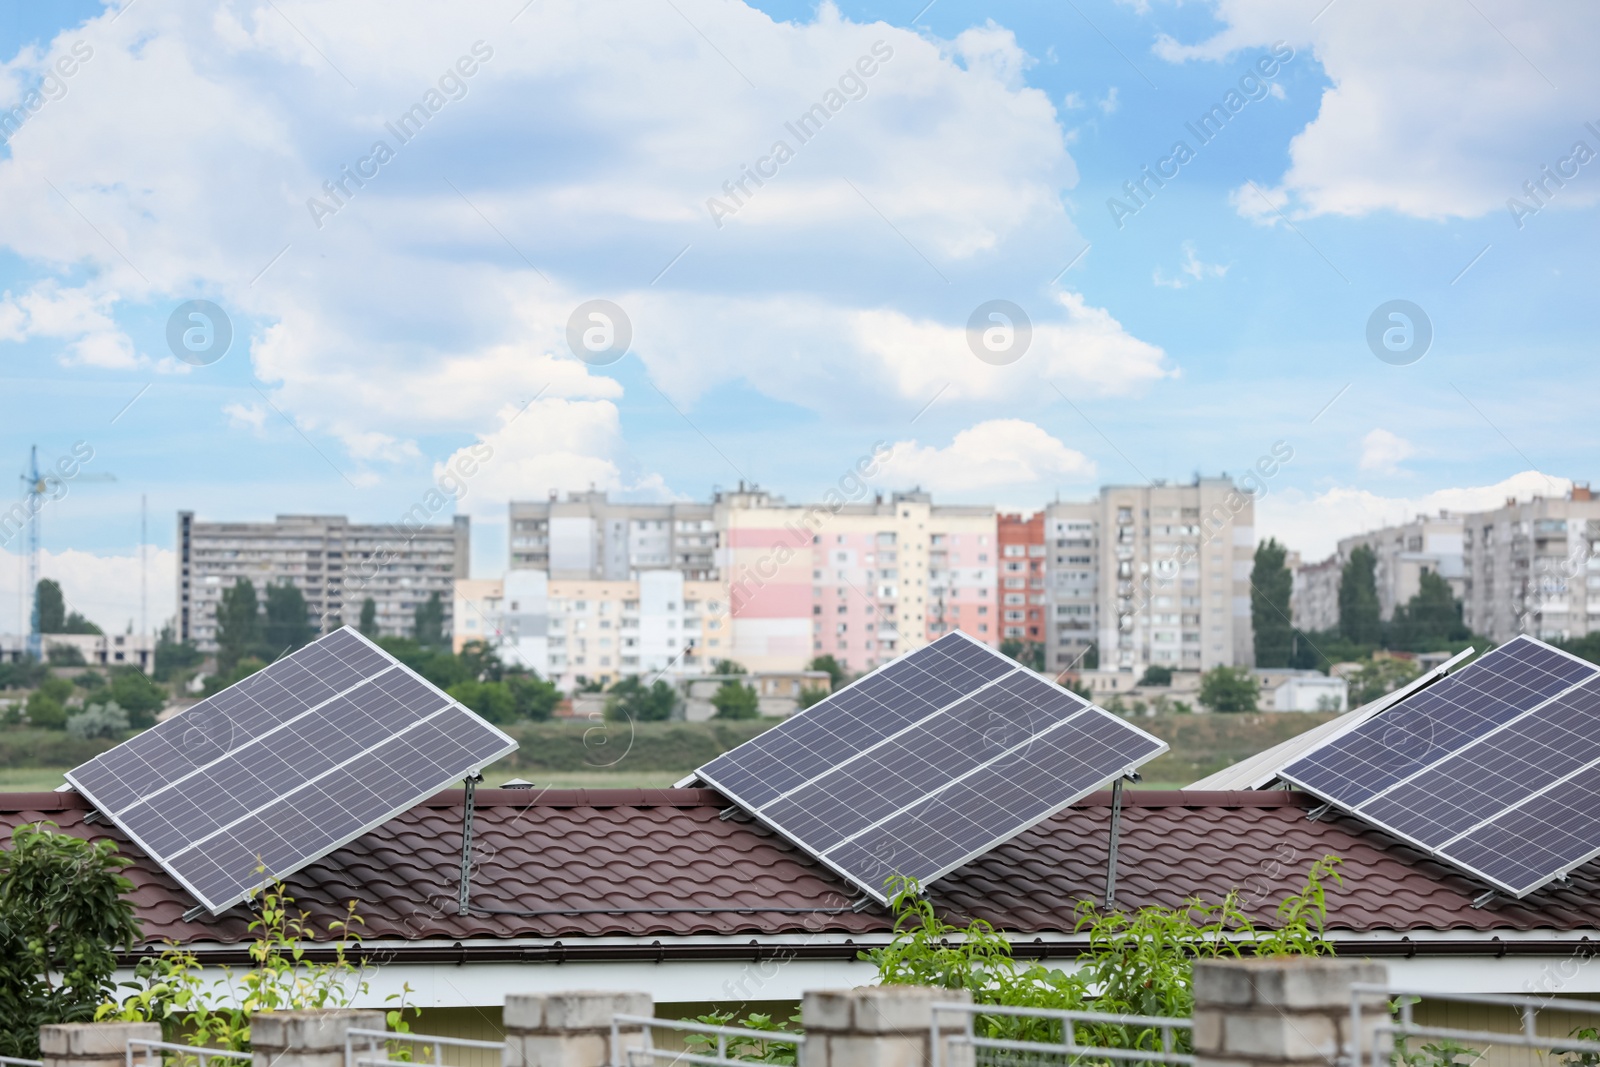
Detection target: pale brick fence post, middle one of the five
<box><xmin>501</xmin><ymin>992</ymin><xmax>654</xmax><ymax>1067</ymax></box>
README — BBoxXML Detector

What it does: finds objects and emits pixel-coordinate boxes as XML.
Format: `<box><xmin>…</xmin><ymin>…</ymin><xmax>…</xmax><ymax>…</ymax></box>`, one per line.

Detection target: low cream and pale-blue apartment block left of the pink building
<box><xmin>473</xmin><ymin>568</ymin><xmax>728</xmax><ymax>691</ymax></box>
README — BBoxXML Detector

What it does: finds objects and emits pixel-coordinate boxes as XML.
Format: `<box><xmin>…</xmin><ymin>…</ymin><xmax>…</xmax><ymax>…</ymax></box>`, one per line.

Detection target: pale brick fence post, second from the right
<box><xmin>800</xmin><ymin>985</ymin><xmax>973</xmax><ymax>1067</ymax></box>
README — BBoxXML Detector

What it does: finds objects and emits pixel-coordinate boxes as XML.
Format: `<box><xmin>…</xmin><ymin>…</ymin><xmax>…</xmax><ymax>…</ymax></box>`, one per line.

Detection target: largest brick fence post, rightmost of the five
<box><xmin>1194</xmin><ymin>957</ymin><xmax>1389</xmax><ymax>1067</ymax></box>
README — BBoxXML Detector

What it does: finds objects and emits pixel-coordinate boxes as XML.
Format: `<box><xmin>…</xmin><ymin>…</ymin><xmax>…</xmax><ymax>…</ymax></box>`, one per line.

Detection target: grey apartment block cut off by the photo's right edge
<box><xmin>1461</xmin><ymin>483</ymin><xmax>1600</xmax><ymax>641</ymax></box>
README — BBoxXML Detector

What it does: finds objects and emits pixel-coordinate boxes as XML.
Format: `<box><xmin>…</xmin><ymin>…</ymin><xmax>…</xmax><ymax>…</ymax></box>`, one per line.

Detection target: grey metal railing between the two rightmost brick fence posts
<box><xmin>928</xmin><ymin>1003</ymin><xmax>1195</xmax><ymax>1067</ymax></box>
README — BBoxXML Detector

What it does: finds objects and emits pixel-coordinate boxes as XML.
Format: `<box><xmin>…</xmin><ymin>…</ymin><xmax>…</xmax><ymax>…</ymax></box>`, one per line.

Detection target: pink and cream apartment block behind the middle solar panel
<box><xmin>714</xmin><ymin>486</ymin><xmax>998</xmax><ymax>672</ymax></box>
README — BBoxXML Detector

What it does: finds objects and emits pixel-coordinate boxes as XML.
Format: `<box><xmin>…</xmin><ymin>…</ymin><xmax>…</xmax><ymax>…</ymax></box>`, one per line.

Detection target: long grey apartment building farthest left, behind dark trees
<box><xmin>178</xmin><ymin>512</ymin><xmax>470</xmax><ymax>653</ymax></box>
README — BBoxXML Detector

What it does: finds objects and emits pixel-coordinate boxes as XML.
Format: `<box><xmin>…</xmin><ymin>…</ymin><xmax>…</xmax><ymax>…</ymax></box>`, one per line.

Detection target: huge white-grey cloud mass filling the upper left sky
<box><xmin>0</xmin><ymin>0</ymin><xmax>1113</xmax><ymax>477</ymax></box>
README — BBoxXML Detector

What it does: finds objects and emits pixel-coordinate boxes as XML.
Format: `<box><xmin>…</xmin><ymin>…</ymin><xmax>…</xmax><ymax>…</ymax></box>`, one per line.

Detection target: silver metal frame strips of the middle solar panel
<box><xmin>677</xmin><ymin>630</ymin><xmax>1171</xmax><ymax>904</ymax></box>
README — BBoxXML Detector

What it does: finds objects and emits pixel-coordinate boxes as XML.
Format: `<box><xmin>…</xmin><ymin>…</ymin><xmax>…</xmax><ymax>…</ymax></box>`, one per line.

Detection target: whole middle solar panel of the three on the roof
<box><xmin>696</xmin><ymin>630</ymin><xmax>1166</xmax><ymax>901</ymax></box>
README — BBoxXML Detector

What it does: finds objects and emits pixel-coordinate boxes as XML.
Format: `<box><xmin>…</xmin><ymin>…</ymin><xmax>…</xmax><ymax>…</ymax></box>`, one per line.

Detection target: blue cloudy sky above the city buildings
<box><xmin>0</xmin><ymin>0</ymin><xmax>1600</xmax><ymax>630</ymax></box>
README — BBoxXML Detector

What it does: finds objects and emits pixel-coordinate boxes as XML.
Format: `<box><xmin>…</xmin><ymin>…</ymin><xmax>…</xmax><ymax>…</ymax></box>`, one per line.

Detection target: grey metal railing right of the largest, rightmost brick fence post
<box><xmin>1342</xmin><ymin>984</ymin><xmax>1600</xmax><ymax>1067</ymax></box>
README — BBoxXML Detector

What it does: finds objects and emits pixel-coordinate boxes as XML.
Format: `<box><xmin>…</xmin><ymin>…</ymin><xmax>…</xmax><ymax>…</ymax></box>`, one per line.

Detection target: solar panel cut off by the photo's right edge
<box><xmin>1280</xmin><ymin>637</ymin><xmax>1600</xmax><ymax>897</ymax></box>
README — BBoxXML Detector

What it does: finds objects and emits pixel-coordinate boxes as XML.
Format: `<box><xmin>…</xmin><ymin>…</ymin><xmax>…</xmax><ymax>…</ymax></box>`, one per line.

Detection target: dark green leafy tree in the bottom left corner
<box><xmin>0</xmin><ymin>822</ymin><xmax>144</xmax><ymax>1059</ymax></box>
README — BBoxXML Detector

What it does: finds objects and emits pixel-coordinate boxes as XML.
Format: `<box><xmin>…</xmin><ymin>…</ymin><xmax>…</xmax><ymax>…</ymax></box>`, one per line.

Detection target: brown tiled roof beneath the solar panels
<box><xmin>12</xmin><ymin>789</ymin><xmax>1600</xmax><ymax>958</ymax></box>
